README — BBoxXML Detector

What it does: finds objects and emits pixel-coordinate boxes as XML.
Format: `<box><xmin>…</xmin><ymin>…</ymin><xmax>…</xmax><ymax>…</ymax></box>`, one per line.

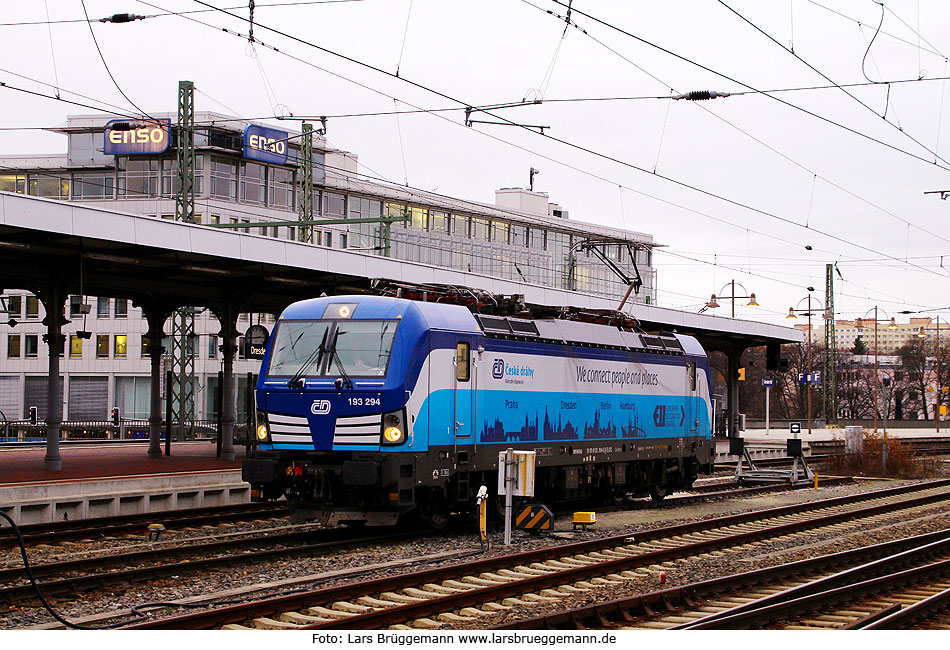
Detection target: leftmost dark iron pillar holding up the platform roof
<box><xmin>35</xmin><ymin>284</ymin><xmax>69</xmax><ymax>471</ymax></box>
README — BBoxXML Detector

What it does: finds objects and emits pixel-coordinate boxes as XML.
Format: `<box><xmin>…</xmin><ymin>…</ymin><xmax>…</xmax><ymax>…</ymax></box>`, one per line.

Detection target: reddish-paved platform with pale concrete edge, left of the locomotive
<box><xmin>0</xmin><ymin>441</ymin><xmax>250</xmax><ymax>524</ymax></box>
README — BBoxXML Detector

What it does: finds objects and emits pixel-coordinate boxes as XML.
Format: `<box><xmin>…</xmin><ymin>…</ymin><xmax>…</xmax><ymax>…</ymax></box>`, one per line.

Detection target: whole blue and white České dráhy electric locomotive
<box><xmin>243</xmin><ymin>296</ymin><xmax>713</xmax><ymax>526</ymax></box>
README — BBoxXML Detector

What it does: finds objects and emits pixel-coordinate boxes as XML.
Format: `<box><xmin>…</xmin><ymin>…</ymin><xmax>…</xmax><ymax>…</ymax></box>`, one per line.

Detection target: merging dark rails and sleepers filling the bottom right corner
<box><xmin>494</xmin><ymin>529</ymin><xmax>950</xmax><ymax>630</ymax></box>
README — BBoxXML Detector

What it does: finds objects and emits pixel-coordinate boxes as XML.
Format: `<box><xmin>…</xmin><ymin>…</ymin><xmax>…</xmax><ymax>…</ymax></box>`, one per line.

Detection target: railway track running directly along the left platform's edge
<box><xmin>0</xmin><ymin>502</ymin><xmax>289</xmax><ymax>549</ymax></box>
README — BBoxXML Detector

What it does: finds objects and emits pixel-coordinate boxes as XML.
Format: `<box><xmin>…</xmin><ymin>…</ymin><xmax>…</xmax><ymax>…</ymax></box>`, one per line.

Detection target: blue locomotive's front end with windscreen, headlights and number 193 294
<box><xmin>243</xmin><ymin>298</ymin><xmax>424</xmax><ymax>525</ymax></box>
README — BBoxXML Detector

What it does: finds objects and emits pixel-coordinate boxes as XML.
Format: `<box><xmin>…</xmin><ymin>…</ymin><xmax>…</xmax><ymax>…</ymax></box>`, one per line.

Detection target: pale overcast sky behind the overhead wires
<box><xmin>0</xmin><ymin>0</ymin><xmax>950</xmax><ymax>324</ymax></box>
